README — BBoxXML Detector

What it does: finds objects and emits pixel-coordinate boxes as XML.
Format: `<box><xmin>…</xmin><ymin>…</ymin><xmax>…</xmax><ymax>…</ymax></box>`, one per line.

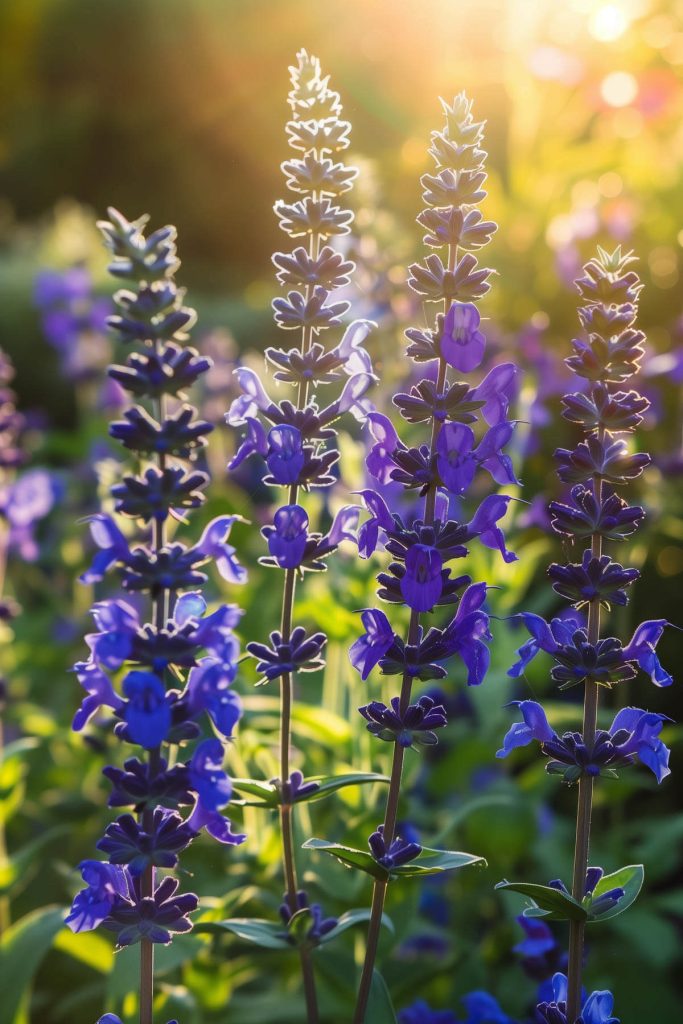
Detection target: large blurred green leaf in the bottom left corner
<box><xmin>0</xmin><ymin>906</ymin><xmax>65</xmax><ymax>1024</ymax></box>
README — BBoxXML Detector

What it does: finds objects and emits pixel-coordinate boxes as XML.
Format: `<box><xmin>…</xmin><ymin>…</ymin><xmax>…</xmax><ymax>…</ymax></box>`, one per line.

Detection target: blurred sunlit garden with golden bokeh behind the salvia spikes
<box><xmin>0</xmin><ymin>0</ymin><xmax>683</xmax><ymax>1024</ymax></box>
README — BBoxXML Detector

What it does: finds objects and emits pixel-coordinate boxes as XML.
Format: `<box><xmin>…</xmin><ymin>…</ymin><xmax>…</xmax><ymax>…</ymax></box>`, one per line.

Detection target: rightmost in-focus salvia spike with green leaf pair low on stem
<box><xmin>499</xmin><ymin>248</ymin><xmax>672</xmax><ymax>1024</ymax></box>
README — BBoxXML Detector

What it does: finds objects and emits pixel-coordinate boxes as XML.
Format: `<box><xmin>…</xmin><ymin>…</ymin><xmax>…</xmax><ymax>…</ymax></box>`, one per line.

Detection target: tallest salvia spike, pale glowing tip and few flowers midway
<box><xmin>226</xmin><ymin>50</ymin><xmax>375</xmax><ymax>1024</ymax></box>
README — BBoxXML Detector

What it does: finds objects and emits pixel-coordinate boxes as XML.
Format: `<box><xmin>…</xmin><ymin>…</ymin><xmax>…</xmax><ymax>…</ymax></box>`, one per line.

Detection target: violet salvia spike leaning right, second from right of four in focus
<box><xmin>350</xmin><ymin>93</ymin><xmax>517</xmax><ymax>1024</ymax></box>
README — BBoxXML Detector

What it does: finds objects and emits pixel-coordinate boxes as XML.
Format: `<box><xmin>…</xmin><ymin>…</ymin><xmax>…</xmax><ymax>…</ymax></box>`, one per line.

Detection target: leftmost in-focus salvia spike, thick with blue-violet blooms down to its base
<box><xmin>67</xmin><ymin>210</ymin><xmax>246</xmax><ymax>1024</ymax></box>
